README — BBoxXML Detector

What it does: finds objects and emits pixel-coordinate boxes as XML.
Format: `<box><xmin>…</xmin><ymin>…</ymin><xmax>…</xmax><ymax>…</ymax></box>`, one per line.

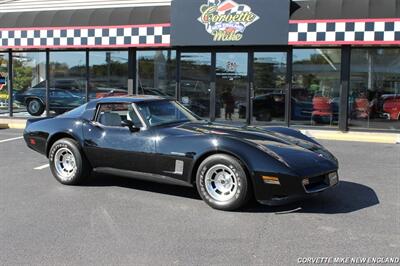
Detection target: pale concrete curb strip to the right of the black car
<box><xmin>301</xmin><ymin>129</ymin><xmax>400</xmax><ymax>144</ymax></box>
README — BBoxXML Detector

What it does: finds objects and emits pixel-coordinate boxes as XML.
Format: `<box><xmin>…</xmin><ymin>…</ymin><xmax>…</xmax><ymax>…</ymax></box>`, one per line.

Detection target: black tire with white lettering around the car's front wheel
<box><xmin>196</xmin><ymin>154</ymin><xmax>252</xmax><ymax>211</ymax></box>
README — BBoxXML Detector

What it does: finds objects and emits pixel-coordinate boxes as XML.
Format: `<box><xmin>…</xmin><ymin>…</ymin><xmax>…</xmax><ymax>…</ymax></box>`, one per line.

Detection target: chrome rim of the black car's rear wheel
<box><xmin>54</xmin><ymin>148</ymin><xmax>78</xmax><ymax>182</ymax></box>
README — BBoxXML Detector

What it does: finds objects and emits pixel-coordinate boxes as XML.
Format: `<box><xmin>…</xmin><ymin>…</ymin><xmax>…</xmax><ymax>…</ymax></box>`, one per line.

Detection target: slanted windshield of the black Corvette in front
<box><xmin>137</xmin><ymin>101</ymin><xmax>199</xmax><ymax>126</ymax></box>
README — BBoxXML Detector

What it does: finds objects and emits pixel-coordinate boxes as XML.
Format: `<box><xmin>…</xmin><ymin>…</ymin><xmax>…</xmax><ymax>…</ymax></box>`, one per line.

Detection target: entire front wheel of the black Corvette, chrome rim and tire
<box><xmin>196</xmin><ymin>154</ymin><xmax>251</xmax><ymax>211</ymax></box>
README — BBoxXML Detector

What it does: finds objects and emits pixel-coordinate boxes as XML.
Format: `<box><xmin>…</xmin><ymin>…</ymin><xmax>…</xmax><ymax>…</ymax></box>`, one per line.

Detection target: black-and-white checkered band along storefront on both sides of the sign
<box><xmin>0</xmin><ymin>19</ymin><xmax>400</xmax><ymax>49</ymax></box>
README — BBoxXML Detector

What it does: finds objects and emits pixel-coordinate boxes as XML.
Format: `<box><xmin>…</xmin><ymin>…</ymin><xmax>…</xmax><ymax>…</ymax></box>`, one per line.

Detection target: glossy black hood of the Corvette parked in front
<box><xmin>180</xmin><ymin>123</ymin><xmax>338</xmax><ymax>174</ymax></box>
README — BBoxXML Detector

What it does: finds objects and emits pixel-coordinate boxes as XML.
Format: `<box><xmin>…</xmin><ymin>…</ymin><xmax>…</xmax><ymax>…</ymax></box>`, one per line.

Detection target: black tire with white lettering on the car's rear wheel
<box><xmin>49</xmin><ymin>138</ymin><xmax>92</xmax><ymax>185</ymax></box>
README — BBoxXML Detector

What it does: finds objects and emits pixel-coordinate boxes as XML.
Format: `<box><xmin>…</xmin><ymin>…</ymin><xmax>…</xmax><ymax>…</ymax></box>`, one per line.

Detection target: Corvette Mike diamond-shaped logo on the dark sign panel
<box><xmin>198</xmin><ymin>0</ymin><xmax>259</xmax><ymax>42</ymax></box>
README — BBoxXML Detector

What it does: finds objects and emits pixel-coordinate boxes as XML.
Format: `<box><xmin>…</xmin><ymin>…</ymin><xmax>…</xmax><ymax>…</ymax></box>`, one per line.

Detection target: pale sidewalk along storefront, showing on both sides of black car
<box><xmin>0</xmin><ymin>118</ymin><xmax>400</xmax><ymax>144</ymax></box>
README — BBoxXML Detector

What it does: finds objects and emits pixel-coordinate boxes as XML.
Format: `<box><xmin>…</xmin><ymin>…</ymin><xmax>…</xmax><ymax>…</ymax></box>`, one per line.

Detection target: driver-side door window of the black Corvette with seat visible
<box><xmin>96</xmin><ymin>103</ymin><xmax>142</xmax><ymax>127</ymax></box>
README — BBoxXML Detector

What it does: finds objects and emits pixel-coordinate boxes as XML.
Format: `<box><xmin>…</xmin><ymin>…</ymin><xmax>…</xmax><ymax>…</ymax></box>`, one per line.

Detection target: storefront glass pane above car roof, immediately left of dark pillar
<box><xmin>89</xmin><ymin>51</ymin><xmax>128</xmax><ymax>99</ymax></box>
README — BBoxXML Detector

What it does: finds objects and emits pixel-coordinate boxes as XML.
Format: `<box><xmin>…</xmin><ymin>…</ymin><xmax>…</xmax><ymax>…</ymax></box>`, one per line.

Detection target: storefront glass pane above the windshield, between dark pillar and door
<box><xmin>137</xmin><ymin>50</ymin><xmax>176</xmax><ymax>97</ymax></box>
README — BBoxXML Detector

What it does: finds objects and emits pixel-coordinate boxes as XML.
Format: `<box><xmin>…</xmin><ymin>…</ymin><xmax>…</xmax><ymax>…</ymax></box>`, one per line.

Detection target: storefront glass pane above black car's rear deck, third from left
<box><xmin>49</xmin><ymin>52</ymin><xmax>86</xmax><ymax>114</ymax></box>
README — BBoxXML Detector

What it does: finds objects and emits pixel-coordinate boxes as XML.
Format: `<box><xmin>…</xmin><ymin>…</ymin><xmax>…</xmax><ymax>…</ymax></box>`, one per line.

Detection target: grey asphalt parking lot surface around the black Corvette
<box><xmin>0</xmin><ymin>129</ymin><xmax>400</xmax><ymax>265</ymax></box>
